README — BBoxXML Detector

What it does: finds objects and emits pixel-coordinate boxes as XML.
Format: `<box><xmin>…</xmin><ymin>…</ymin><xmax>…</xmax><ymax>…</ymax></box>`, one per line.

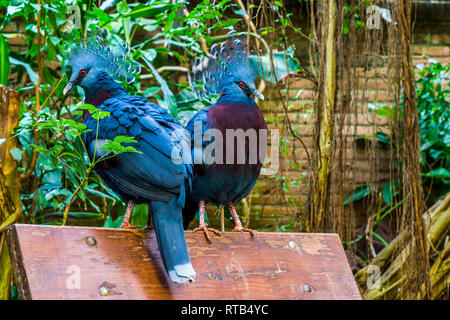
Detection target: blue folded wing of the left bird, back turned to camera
<box><xmin>86</xmin><ymin>95</ymin><xmax>192</xmax><ymax>202</ymax></box>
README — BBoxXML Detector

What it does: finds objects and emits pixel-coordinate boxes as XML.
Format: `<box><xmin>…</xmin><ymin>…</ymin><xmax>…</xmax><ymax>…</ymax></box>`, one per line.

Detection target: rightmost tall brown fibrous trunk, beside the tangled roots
<box><xmin>397</xmin><ymin>0</ymin><xmax>432</xmax><ymax>299</ymax></box>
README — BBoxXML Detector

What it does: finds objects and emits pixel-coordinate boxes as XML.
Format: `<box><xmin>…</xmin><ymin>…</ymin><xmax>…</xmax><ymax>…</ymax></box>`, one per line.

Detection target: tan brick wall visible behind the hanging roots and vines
<box><xmin>203</xmin><ymin>4</ymin><xmax>450</xmax><ymax>231</ymax></box>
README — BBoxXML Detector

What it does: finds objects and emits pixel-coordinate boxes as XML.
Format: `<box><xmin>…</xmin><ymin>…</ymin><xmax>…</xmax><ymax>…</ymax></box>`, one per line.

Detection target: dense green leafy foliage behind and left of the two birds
<box><xmin>0</xmin><ymin>0</ymin><xmax>299</xmax><ymax>227</ymax></box>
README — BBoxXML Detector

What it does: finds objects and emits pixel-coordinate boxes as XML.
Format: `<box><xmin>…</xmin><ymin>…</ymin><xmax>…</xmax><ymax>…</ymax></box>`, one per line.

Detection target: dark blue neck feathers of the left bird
<box><xmin>83</xmin><ymin>72</ymin><xmax>125</xmax><ymax>107</ymax></box>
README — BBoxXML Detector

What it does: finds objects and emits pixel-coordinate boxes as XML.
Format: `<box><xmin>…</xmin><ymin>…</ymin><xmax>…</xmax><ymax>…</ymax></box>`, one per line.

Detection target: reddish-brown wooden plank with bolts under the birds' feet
<box><xmin>7</xmin><ymin>224</ymin><xmax>361</xmax><ymax>300</ymax></box>
